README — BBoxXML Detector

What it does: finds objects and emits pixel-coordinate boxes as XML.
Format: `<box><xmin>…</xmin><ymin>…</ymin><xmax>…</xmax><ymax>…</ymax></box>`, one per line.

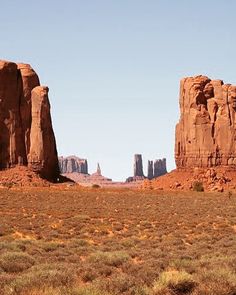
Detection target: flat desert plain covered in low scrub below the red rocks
<box><xmin>0</xmin><ymin>188</ymin><xmax>236</xmax><ymax>295</ymax></box>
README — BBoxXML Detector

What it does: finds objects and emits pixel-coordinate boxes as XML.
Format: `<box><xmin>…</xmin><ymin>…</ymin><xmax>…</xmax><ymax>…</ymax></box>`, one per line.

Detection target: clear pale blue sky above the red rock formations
<box><xmin>0</xmin><ymin>0</ymin><xmax>236</xmax><ymax>180</ymax></box>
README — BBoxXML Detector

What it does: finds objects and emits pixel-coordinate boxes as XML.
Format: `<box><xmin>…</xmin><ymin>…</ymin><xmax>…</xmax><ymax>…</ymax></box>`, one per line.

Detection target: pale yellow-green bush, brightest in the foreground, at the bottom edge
<box><xmin>153</xmin><ymin>270</ymin><xmax>196</xmax><ymax>294</ymax></box>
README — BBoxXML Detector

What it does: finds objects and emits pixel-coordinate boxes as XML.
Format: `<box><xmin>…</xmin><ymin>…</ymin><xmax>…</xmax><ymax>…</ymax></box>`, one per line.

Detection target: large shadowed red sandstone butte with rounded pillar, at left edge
<box><xmin>0</xmin><ymin>60</ymin><xmax>59</xmax><ymax>181</ymax></box>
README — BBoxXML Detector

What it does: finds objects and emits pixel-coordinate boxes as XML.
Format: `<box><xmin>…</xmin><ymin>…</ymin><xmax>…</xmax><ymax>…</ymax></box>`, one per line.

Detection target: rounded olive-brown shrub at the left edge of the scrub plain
<box><xmin>0</xmin><ymin>252</ymin><xmax>35</xmax><ymax>273</ymax></box>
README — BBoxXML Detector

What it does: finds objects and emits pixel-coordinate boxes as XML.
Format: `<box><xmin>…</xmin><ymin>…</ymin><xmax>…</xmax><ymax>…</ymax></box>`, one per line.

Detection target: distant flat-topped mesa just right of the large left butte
<box><xmin>59</xmin><ymin>156</ymin><xmax>88</xmax><ymax>174</ymax></box>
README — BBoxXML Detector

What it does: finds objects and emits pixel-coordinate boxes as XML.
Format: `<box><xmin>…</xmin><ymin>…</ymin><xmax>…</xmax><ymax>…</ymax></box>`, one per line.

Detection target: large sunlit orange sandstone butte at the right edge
<box><xmin>175</xmin><ymin>76</ymin><xmax>236</xmax><ymax>168</ymax></box>
